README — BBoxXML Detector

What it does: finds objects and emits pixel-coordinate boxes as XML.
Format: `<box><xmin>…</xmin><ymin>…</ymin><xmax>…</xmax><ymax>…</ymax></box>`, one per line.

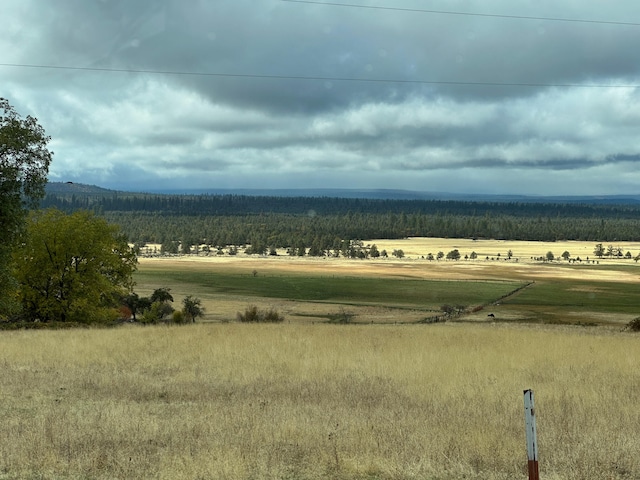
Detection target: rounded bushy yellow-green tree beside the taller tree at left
<box><xmin>14</xmin><ymin>210</ymin><xmax>137</xmax><ymax>323</ymax></box>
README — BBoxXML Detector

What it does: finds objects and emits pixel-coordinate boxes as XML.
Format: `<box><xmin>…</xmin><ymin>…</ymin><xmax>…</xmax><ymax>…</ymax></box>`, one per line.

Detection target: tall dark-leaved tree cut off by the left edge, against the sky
<box><xmin>0</xmin><ymin>98</ymin><xmax>53</xmax><ymax>316</ymax></box>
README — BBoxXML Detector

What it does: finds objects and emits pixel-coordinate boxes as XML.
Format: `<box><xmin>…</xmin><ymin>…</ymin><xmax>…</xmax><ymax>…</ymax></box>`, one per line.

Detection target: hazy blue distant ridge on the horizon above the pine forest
<box><xmin>46</xmin><ymin>182</ymin><xmax>640</xmax><ymax>205</ymax></box>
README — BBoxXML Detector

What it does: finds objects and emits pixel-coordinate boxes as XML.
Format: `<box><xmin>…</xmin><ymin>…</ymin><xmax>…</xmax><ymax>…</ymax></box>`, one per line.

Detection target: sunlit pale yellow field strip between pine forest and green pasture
<box><xmin>140</xmin><ymin>238</ymin><xmax>640</xmax><ymax>282</ymax></box>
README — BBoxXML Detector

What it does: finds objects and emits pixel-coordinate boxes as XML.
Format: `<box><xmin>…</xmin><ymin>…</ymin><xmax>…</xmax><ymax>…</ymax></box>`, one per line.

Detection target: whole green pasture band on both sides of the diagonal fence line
<box><xmin>135</xmin><ymin>266</ymin><xmax>640</xmax><ymax>325</ymax></box>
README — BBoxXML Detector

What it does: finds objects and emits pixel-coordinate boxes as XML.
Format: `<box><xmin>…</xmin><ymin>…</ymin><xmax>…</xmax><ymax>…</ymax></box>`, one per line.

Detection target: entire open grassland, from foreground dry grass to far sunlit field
<box><xmin>0</xmin><ymin>239</ymin><xmax>640</xmax><ymax>480</ymax></box>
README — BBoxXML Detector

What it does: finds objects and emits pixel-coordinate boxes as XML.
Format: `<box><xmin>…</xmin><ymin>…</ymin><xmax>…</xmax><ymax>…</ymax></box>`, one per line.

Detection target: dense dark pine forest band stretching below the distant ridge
<box><xmin>42</xmin><ymin>185</ymin><xmax>640</xmax><ymax>255</ymax></box>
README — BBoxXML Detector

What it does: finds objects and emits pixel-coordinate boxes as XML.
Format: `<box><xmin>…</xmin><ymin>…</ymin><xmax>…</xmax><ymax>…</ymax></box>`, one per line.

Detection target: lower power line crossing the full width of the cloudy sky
<box><xmin>0</xmin><ymin>63</ymin><xmax>640</xmax><ymax>88</ymax></box>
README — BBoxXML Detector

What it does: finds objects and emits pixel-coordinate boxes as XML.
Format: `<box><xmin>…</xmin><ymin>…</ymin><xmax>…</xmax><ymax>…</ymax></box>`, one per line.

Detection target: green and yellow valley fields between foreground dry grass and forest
<box><xmin>136</xmin><ymin>238</ymin><xmax>640</xmax><ymax>326</ymax></box>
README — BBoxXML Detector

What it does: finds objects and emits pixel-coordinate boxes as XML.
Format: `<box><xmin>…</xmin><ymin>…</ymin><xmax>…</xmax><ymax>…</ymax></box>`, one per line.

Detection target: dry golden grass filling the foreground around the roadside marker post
<box><xmin>0</xmin><ymin>323</ymin><xmax>640</xmax><ymax>480</ymax></box>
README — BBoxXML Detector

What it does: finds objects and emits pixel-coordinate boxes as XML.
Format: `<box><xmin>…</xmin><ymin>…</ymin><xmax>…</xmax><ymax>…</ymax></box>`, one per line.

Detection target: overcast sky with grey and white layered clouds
<box><xmin>0</xmin><ymin>0</ymin><xmax>640</xmax><ymax>195</ymax></box>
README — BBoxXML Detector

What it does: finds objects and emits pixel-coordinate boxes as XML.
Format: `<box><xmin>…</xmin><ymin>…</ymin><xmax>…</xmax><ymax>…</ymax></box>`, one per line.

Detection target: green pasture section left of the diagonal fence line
<box><xmin>135</xmin><ymin>268</ymin><xmax>524</xmax><ymax>310</ymax></box>
